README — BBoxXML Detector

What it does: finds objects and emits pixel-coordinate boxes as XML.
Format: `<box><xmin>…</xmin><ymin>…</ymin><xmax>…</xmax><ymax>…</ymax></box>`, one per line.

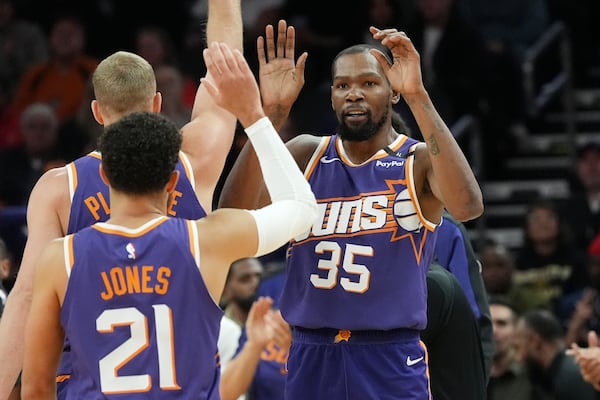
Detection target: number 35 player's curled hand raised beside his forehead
<box><xmin>369</xmin><ymin>26</ymin><xmax>425</xmax><ymax>96</ymax></box>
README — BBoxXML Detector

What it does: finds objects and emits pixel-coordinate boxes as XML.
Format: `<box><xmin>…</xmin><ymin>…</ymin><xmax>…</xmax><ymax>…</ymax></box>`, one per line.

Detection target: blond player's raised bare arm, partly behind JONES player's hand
<box><xmin>182</xmin><ymin>0</ymin><xmax>243</xmax><ymax>212</ymax></box>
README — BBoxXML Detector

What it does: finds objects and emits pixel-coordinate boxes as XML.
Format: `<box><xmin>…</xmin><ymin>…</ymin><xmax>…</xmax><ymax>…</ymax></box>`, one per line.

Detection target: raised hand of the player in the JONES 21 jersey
<box><xmin>201</xmin><ymin>42</ymin><xmax>265</xmax><ymax>127</ymax></box>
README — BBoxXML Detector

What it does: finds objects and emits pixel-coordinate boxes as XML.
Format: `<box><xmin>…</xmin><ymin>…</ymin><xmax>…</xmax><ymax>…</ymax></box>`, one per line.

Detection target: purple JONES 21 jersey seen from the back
<box><xmin>61</xmin><ymin>217</ymin><xmax>223</xmax><ymax>399</ymax></box>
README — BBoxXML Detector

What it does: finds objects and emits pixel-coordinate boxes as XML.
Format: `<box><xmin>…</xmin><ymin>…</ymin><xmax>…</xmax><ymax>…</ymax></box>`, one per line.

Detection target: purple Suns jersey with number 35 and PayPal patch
<box><xmin>281</xmin><ymin>135</ymin><xmax>437</xmax><ymax>330</ymax></box>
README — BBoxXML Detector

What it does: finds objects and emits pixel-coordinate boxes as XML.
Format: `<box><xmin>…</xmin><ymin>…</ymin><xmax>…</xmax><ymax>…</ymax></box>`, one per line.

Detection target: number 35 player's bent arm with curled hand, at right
<box><xmin>370</xmin><ymin>27</ymin><xmax>483</xmax><ymax>221</ymax></box>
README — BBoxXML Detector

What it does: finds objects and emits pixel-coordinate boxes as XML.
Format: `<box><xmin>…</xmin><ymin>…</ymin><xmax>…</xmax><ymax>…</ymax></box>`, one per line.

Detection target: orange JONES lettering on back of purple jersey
<box><xmin>100</xmin><ymin>265</ymin><xmax>171</xmax><ymax>300</ymax></box>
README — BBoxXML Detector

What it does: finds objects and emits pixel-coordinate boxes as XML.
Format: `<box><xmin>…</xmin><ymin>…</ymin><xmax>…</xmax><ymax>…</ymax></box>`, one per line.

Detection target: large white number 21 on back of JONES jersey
<box><xmin>96</xmin><ymin>304</ymin><xmax>181</xmax><ymax>394</ymax></box>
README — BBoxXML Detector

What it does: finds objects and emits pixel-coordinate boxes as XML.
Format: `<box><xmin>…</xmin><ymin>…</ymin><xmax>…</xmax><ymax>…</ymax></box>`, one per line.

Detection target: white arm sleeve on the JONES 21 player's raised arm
<box><xmin>246</xmin><ymin>117</ymin><xmax>317</xmax><ymax>256</ymax></box>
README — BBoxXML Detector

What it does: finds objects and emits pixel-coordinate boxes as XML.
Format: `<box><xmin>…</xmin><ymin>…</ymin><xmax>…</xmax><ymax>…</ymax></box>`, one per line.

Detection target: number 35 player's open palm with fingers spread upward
<box><xmin>256</xmin><ymin>20</ymin><xmax>308</xmax><ymax>128</ymax></box>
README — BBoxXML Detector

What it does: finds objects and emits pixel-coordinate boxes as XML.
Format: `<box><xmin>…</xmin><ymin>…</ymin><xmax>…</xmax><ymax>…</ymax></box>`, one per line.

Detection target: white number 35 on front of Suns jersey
<box><xmin>310</xmin><ymin>241</ymin><xmax>373</xmax><ymax>293</ymax></box>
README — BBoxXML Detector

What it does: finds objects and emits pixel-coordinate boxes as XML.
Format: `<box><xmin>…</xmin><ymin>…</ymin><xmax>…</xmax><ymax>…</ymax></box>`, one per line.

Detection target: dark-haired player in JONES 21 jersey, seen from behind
<box><xmin>23</xmin><ymin>43</ymin><xmax>316</xmax><ymax>399</ymax></box>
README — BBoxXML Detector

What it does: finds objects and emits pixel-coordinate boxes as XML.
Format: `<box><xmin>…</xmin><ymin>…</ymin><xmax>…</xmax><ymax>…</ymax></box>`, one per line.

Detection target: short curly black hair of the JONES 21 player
<box><xmin>99</xmin><ymin>112</ymin><xmax>182</xmax><ymax>194</ymax></box>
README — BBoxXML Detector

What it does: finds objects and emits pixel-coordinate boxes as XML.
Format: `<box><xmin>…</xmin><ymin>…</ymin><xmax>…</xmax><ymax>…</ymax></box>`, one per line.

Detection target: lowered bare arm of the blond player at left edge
<box><xmin>0</xmin><ymin>168</ymin><xmax>68</xmax><ymax>399</ymax></box>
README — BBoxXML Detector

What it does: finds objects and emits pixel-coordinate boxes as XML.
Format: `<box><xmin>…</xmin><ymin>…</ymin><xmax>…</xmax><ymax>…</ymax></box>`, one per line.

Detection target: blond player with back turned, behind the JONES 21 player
<box><xmin>0</xmin><ymin>0</ymin><xmax>242</xmax><ymax>399</ymax></box>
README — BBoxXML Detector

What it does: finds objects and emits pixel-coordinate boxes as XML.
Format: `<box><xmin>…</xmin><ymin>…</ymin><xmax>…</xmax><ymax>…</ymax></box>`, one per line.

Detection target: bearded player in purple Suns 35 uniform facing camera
<box><xmin>220</xmin><ymin>27</ymin><xmax>483</xmax><ymax>400</ymax></box>
